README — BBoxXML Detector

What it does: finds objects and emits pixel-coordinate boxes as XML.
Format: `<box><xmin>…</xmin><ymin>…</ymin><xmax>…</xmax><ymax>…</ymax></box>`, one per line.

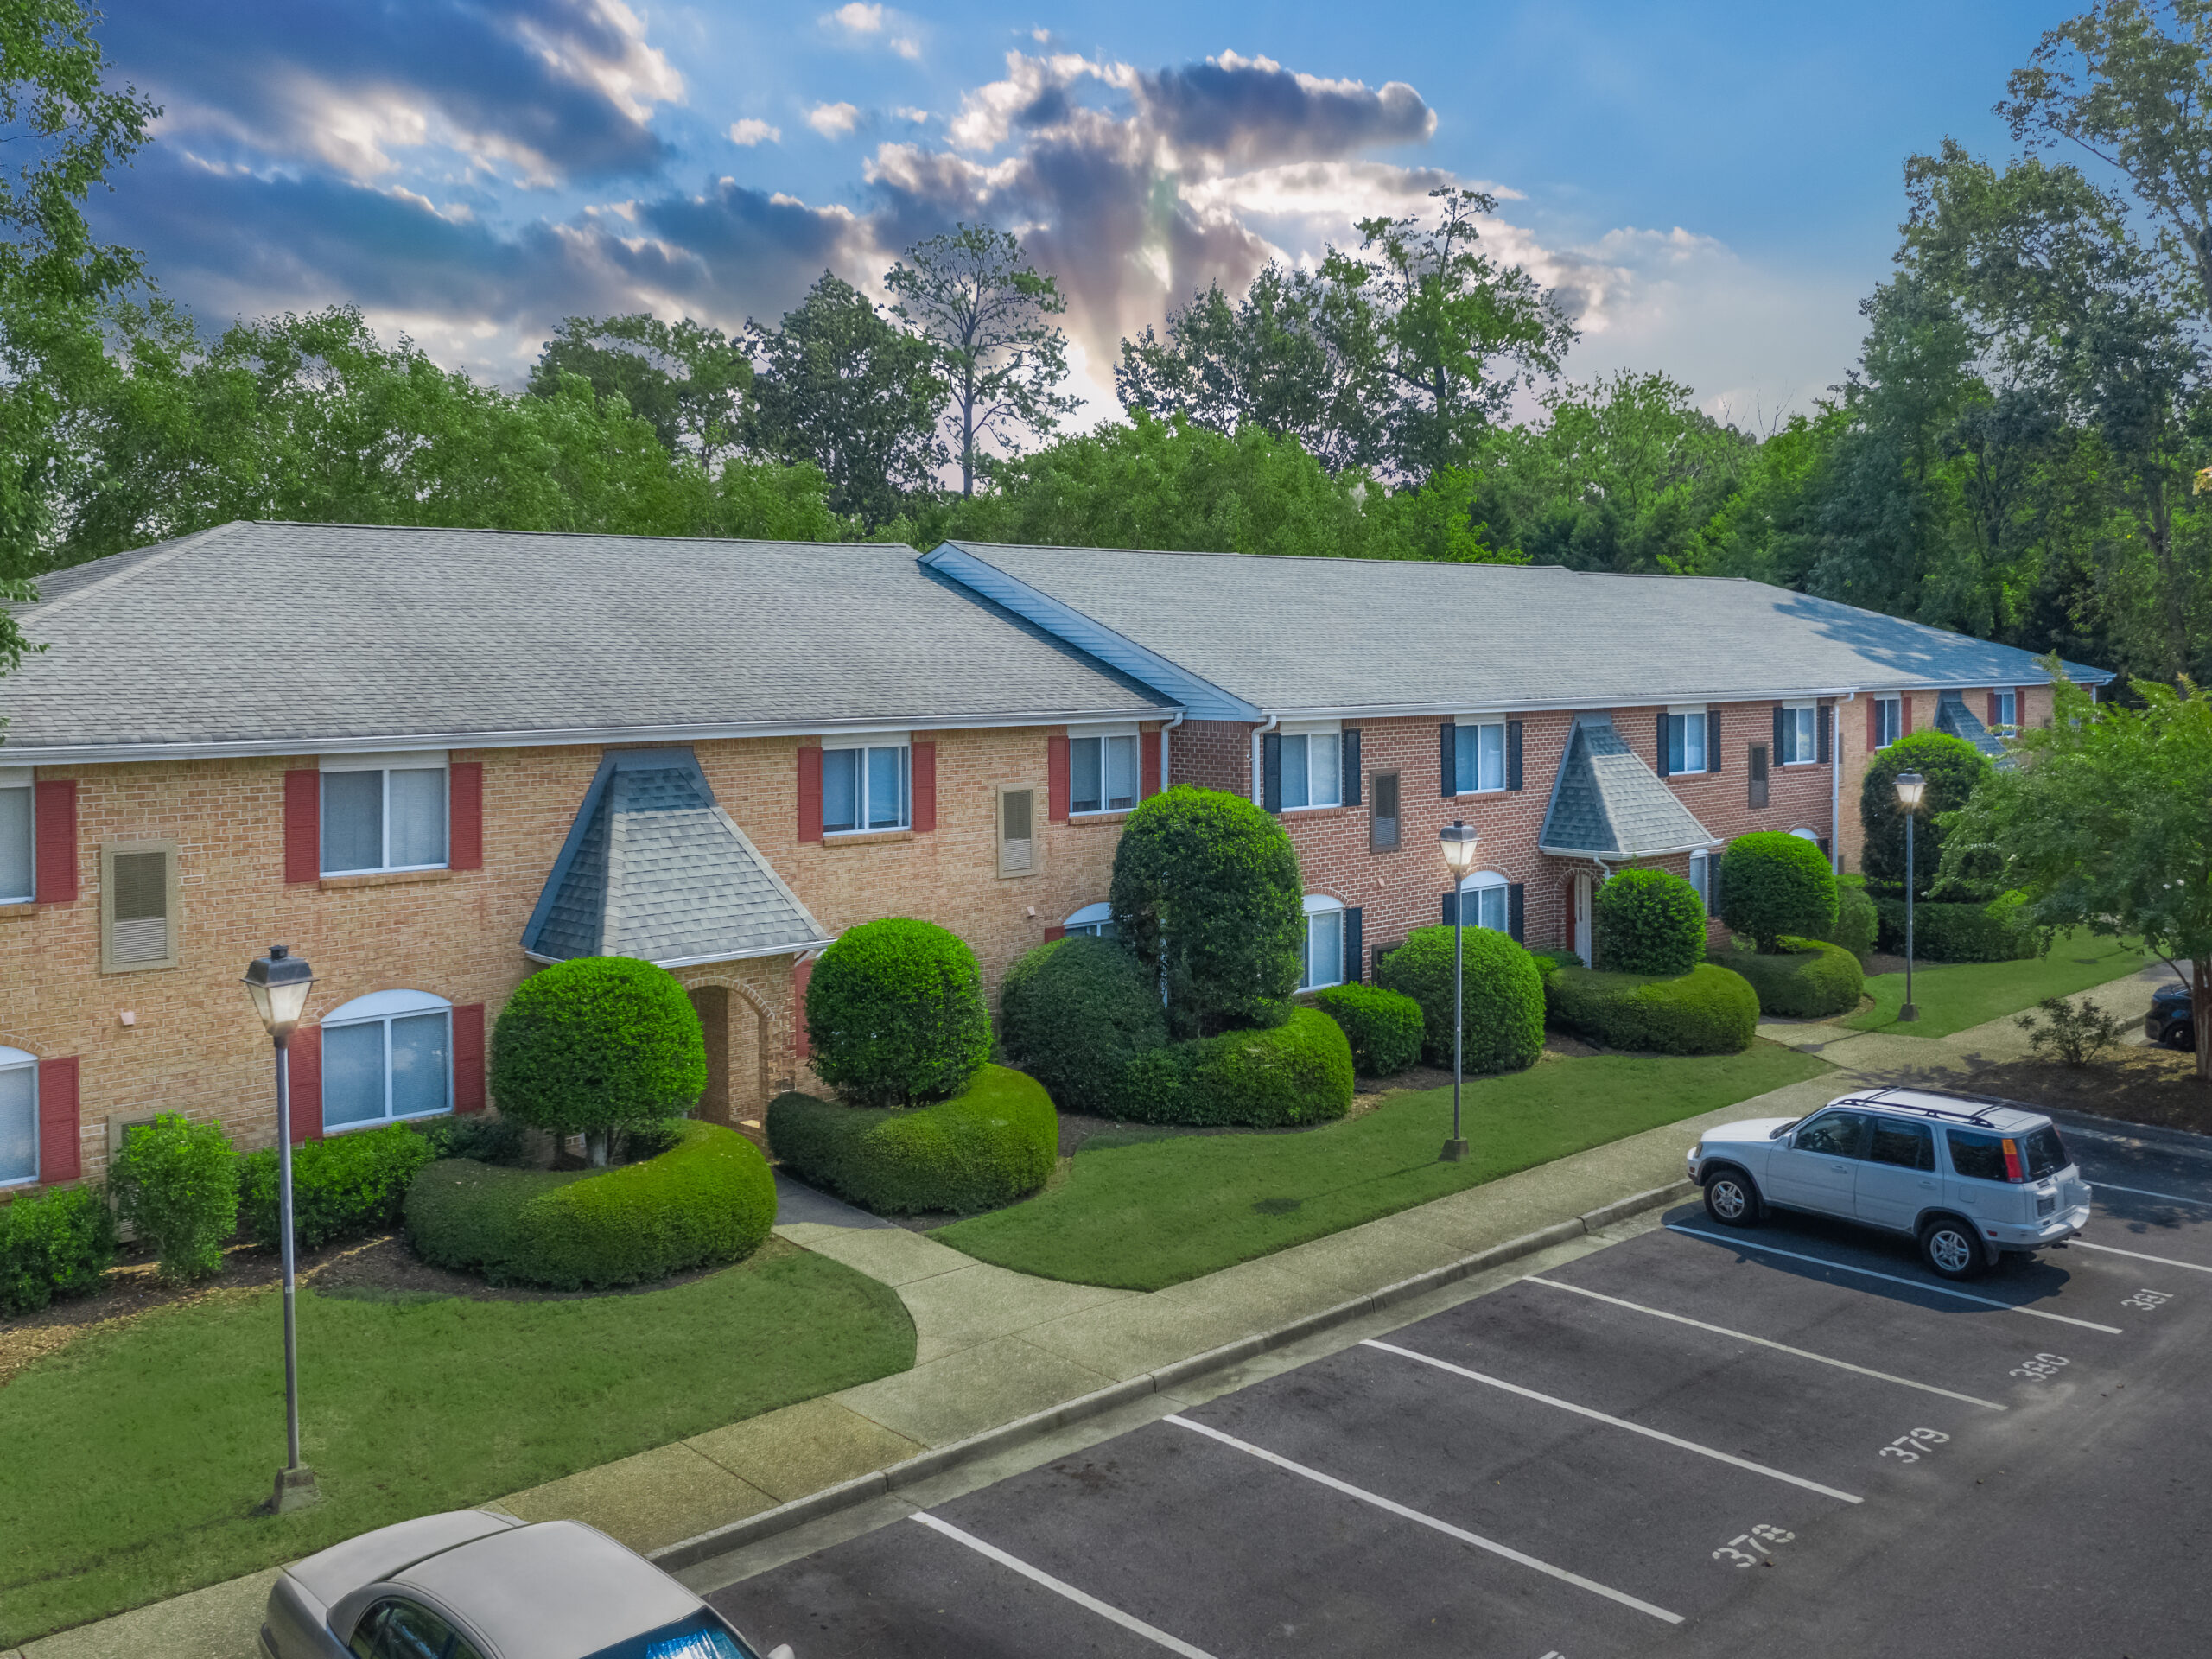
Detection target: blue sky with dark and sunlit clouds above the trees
<box><xmin>78</xmin><ymin>0</ymin><xmax>2073</xmax><ymax>427</ymax></box>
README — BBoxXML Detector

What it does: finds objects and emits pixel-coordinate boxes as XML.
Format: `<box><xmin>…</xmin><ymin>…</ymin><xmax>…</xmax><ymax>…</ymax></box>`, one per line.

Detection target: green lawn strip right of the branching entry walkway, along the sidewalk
<box><xmin>931</xmin><ymin>1042</ymin><xmax>1827</xmax><ymax>1289</ymax></box>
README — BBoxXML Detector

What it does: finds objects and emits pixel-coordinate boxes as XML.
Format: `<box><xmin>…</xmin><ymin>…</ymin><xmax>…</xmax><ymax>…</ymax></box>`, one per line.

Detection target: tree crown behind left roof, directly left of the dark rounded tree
<box><xmin>529</xmin><ymin>312</ymin><xmax>752</xmax><ymax>471</ymax></box>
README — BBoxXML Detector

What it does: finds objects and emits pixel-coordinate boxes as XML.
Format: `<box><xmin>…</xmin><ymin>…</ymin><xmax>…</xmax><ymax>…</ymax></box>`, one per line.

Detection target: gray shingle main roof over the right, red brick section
<box><xmin>925</xmin><ymin>542</ymin><xmax>2110</xmax><ymax>716</ymax></box>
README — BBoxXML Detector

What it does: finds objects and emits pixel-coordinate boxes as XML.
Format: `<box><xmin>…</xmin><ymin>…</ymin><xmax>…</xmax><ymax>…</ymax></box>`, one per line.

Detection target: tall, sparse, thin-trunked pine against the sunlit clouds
<box><xmin>882</xmin><ymin>226</ymin><xmax>1077</xmax><ymax>495</ymax></box>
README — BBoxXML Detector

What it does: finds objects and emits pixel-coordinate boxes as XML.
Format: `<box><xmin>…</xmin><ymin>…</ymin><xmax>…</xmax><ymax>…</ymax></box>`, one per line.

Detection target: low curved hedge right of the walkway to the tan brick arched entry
<box><xmin>767</xmin><ymin>1066</ymin><xmax>1059</xmax><ymax>1214</ymax></box>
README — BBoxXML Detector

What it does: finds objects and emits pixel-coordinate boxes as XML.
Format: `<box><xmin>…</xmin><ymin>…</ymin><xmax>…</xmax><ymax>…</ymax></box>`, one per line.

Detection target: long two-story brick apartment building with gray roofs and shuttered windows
<box><xmin>0</xmin><ymin>524</ymin><xmax>2106</xmax><ymax>1190</ymax></box>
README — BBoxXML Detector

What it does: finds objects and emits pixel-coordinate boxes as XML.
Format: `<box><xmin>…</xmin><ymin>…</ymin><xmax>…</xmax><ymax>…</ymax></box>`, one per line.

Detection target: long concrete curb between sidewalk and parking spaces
<box><xmin>646</xmin><ymin>1181</ymin><xmax>1697</xmax><ymax>1573</ymax></box>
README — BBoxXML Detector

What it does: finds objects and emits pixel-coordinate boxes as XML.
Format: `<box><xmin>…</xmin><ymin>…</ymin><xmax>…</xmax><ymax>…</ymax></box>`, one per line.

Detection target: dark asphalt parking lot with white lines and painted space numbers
<box><xmin>712</xmin><ymin>1126</ymin><xmax>2212</xmax><ymax>1659</ymax></box>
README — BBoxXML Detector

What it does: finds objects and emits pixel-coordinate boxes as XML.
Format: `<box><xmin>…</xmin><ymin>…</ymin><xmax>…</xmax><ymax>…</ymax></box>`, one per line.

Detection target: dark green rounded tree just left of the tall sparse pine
<box><xmin>746</xmin><ymin>270</ymin><xmax>947</xmax><ymax>529</ymax></box>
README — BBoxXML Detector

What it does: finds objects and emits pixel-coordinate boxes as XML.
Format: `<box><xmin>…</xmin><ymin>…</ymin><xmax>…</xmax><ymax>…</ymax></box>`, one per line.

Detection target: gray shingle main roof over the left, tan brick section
<box><xmin>0</xmin><ymin>524</ymin><xmax>1164</xmax><ymax>761</ymax></box>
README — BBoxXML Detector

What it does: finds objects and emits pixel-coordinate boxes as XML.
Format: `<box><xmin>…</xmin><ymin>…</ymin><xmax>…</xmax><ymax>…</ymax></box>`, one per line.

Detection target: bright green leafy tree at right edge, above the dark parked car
<box><xmin>1942</xmin><ymin>657</ymin><xmax>2212</xmax><ymax>1082</ymax></box>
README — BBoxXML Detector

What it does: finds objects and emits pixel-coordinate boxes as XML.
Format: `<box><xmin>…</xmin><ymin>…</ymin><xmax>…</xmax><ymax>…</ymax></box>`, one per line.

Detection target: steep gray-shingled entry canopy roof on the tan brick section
<box><xmin>522</xmin><ymin>750</ymin><xmax>830</xmax><ymax>967</ymax></box>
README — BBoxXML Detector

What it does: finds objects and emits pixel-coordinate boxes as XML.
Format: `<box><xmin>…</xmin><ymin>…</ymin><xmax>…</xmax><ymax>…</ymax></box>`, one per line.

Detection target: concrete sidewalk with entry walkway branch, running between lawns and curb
<box><xmin>17</xmin><ymin>967</ymin><xmax>2170</xmax><ymax>1659</ymax></box>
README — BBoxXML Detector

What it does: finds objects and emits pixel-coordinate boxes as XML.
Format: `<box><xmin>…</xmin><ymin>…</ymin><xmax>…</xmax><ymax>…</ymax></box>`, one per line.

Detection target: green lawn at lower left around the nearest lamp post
<box><xmin>0</xmin><ymin>1239</ymin><xmax>913</xmax><ymax>1648</ymax></box>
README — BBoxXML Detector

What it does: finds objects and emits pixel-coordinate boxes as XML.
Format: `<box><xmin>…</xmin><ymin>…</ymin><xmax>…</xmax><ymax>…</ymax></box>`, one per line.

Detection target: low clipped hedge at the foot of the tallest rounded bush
<box><xmin>1115</xmin><ymin>1008</ymin><xmax>1351</xmax><ymax>1128</ymax></box>
